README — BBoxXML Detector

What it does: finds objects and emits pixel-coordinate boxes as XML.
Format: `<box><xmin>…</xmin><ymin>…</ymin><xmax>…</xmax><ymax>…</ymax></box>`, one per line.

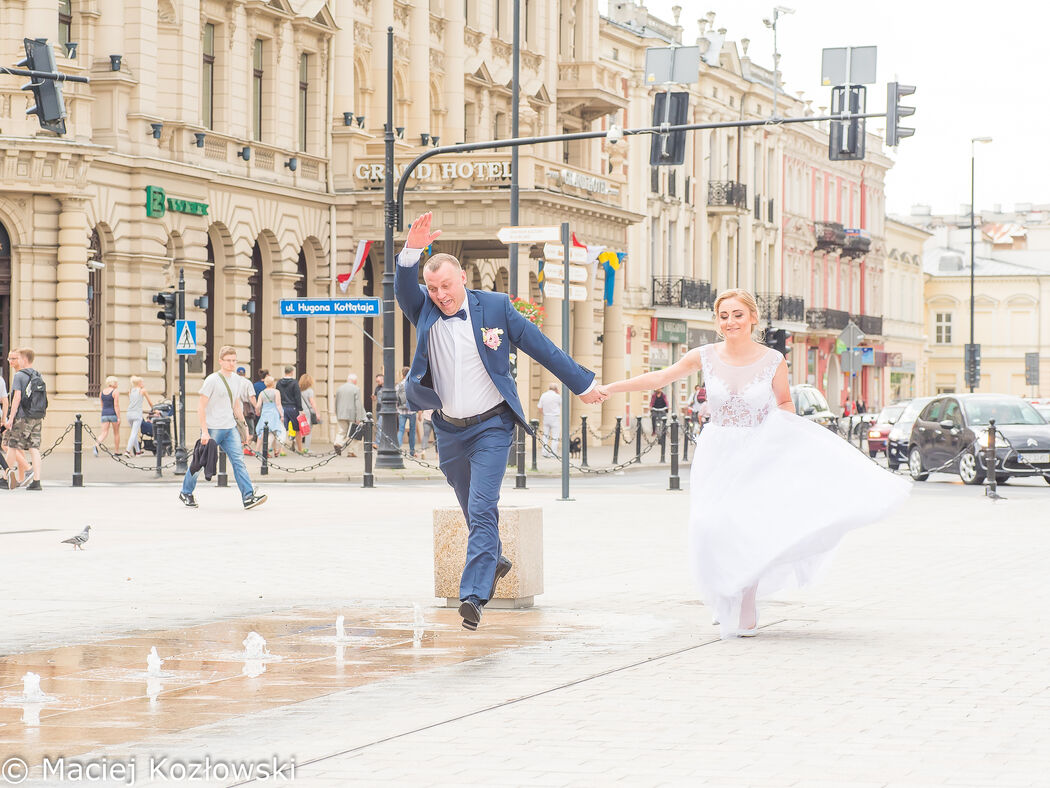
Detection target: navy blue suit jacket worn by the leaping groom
<box><xmin>394</xmin><ymin>257</ymin><xmax>594</xmax><ymax>433</ymax></box>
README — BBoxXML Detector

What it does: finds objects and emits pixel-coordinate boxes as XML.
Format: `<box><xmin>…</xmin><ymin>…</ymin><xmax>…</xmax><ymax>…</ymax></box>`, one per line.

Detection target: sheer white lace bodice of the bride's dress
<box><xmin>700</xmin><ymin>345</ymin><xmax>783</xmax><ymax>427</ymax></box>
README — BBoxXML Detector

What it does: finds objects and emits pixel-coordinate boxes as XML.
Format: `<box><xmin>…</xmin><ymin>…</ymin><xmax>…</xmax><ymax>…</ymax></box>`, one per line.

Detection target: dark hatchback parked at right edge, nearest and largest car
<box><xmin>908</xmin><ymin>394</ymin><xmax>1050</xmax><ymax>484</ymax></box>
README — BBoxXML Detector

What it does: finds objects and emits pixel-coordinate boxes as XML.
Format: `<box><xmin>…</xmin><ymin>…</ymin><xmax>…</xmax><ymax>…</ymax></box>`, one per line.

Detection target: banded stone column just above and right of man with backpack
<box><xmin>55</xmin><ymin>196</ymin><xmax>88</xmax><ymax>397</ymax></box>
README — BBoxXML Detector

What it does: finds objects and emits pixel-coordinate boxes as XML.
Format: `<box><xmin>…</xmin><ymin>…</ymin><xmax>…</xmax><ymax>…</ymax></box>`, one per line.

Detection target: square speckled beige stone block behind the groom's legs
<box><xmin>434</xmin><ymin>506</ymin><xmax>543</xmax><ymax>608</ymax></box>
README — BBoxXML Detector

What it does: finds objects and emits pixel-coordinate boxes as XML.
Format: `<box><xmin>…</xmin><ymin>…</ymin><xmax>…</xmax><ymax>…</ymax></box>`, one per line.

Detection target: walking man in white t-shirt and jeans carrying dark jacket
<box><xmin>179</xmin><ymin>346</ymin><xmax>266</xmax><ymax>509</ymax></box>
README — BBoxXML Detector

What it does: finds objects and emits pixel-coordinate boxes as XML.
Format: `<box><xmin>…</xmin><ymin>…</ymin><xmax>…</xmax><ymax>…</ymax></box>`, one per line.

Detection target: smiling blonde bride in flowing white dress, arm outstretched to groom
<box><xmin>599</xmin><ymin>290</ymin><xmax>911</xmax><ymax>638</ymax></box>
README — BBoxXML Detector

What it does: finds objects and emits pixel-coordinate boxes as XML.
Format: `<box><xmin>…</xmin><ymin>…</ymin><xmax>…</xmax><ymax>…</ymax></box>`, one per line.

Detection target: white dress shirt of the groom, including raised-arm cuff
<box><xmin>397</xmin><ymin>247</ymin><xmax>504</xmax><ymax>418</ymax></box>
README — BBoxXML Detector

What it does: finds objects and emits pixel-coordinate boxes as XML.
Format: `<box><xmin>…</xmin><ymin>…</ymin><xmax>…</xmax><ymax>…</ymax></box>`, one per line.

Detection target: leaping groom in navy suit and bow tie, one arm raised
<box><xmin>394</xmin><ymin>212</ymin><xmax>605</xmax><ymax>630</ymax></box>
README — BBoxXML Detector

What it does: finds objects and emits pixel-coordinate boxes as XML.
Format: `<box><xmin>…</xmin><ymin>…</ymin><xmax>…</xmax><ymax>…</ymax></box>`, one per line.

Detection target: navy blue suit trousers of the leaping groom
<box><xmin>433</xmin><ymin>409</ymin><xmax>515</xmax><ymax>603</ymax></box>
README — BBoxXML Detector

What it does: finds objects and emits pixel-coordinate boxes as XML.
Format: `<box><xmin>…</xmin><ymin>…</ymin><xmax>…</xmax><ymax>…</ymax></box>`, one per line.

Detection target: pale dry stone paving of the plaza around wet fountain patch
<box><xmin>0</xmin><ymin>472</ymin><xmax>1050</xmax><ymax>787</ymax></box>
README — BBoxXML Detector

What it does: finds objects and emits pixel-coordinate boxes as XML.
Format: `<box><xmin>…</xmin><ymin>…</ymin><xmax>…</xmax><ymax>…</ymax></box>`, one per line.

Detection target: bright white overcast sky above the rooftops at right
<box><xmin>601</xmin><ymin>0</ymin><xmax>1050</xmax><ymax>213</ymax></box>
